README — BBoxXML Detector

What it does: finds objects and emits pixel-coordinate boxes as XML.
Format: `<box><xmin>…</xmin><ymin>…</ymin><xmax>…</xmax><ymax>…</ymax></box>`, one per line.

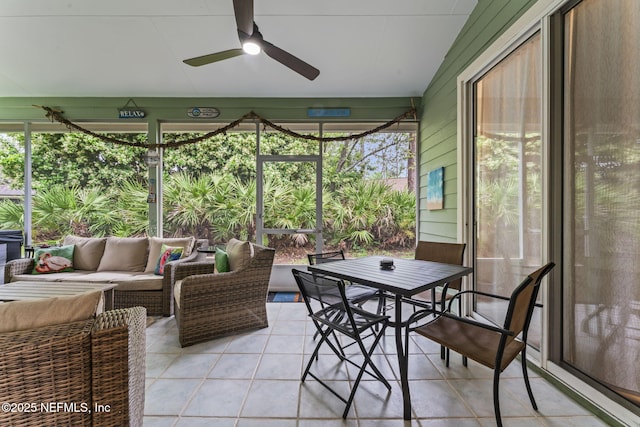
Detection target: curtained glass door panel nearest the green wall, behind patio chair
<box><xmin>472</xmin><ymin>33</ymin><xmax>543</xmax><ymax>347</ymax></box>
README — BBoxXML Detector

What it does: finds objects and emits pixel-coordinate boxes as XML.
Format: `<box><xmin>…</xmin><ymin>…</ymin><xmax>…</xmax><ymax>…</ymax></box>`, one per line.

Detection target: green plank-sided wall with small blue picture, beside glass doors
<box><xmin>418</xmin><ymin>0</ymin><xmax>537</xmax><ymax>242</ymax></box>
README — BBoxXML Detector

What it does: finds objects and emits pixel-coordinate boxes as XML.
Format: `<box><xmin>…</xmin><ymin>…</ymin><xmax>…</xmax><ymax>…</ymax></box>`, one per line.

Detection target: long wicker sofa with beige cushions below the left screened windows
<box><xmin>4</xmin><ymin>236</ymin><xmax>209</xmax><ymax>316</ymax></box>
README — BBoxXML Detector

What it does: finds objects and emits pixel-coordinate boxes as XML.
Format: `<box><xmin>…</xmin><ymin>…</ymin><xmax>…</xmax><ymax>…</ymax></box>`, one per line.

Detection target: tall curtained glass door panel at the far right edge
<box><xmin>563</xmin><ymin>0</ymin><xmax>640</xmax><ymax>405</ymax></box>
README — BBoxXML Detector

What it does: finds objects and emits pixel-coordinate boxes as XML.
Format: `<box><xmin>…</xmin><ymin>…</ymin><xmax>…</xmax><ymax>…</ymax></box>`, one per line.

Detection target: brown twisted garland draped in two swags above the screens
<box><xmin>34</xmin><ymin>105</ymin><xmax>416</xmax><ymax>148</ymax></box>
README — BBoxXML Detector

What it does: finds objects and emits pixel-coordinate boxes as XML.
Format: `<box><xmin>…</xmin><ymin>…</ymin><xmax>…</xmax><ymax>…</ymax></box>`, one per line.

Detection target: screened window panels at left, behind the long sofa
<box><xmin>0</xmin><ymin>128</ymin><xmax>149</xmax><ymax>244</ymax></box>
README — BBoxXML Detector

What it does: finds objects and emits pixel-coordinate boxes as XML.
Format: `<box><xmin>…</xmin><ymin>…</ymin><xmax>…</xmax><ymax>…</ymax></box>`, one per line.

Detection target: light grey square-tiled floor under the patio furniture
<box><xmin>144</xmin><ymin>303</ymin><xmax>607</xmax><ymax>427</ymax></box>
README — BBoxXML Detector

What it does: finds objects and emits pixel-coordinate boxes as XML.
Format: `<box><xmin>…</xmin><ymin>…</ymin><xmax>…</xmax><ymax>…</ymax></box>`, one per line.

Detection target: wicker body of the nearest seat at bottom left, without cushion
<box><xmin>0</xmin><ymin>307</ymin><xmax>146</xmax><ymax>427</ymax></box>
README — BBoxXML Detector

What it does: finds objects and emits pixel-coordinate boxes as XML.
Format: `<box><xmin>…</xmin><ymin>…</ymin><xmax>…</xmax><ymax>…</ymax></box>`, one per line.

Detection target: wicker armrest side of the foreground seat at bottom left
<box><xmin>91</xmin><ymin>307</ymin><xmax>147</xmax><ymax>426</ymax></box>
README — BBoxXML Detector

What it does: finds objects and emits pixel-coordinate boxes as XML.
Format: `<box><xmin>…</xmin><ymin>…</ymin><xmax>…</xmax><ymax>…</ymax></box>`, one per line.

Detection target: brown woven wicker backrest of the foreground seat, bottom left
<box><xmin>0</xmin><ymin>320</ymin><xmax>93</xmax><ymax>426</ymax></box>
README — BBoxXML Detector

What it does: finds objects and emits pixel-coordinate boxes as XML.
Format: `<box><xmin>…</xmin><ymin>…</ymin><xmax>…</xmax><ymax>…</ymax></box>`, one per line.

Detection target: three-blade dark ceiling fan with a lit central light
<box><xmin>183</xmin><ymin>0</ymin><xmax>320</xmax><ymax>80</ymax></box>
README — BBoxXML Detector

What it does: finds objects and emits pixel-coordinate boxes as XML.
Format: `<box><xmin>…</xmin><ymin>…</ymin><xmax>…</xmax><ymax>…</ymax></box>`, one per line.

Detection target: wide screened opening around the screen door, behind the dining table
<box><xmin>162</xmin><ymin>123</ymin><xmax>416</xmax><ymax>264</ymax></box>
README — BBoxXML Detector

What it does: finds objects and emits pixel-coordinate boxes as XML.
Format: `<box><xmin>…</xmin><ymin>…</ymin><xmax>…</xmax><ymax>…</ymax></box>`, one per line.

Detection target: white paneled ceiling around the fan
<box><xmin>0</xmin><ymin>0</ymin><xmax>476</xmax><ymax>97</ymax></box>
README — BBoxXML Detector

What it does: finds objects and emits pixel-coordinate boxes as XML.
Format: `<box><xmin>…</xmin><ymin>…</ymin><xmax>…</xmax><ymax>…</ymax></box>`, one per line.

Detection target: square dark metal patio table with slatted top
<box><xmin>307</xmin><ymin>256</ymin><xmax>473</xmax><ymax>420</ymax></box>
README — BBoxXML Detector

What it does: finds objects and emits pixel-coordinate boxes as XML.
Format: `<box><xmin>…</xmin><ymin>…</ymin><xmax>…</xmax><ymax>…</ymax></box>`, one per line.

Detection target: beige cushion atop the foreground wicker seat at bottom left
<box><xmin>0</xmin><ymin>291</ymin><xmax>102</xmax><ymax>332</ymax></box>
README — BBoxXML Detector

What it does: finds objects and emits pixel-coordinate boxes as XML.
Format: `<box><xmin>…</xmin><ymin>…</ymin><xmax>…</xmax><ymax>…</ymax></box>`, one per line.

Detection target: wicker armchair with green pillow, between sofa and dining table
<box><xmin>174</xmin><ymin>245</ymin><xmax>275</xmax><ymax>347</ymax></box>
